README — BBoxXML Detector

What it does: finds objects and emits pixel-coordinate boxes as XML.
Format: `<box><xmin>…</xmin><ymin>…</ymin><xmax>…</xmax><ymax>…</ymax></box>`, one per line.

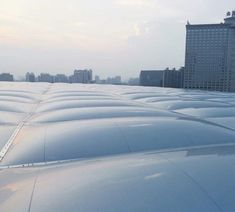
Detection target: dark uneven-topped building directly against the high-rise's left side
<box><xmin>163</xmin><ymin>68</ymin><xmax>184</xmax><ymax>88</ymax></box>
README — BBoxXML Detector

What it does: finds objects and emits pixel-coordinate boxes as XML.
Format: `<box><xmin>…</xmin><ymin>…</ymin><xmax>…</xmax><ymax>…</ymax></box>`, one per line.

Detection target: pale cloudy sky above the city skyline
<box><xmin>0</xmin><ymin>0</ymin><xmax>235</xmax><ymax>79</ymax></box>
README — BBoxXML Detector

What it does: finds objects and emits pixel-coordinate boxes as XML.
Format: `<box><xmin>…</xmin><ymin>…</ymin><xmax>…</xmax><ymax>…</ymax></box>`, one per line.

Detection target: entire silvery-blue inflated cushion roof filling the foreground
<box><xmin>0</xmin><ymin>83</ymin><xmax>235</xmax><ymax>211</ymax></box>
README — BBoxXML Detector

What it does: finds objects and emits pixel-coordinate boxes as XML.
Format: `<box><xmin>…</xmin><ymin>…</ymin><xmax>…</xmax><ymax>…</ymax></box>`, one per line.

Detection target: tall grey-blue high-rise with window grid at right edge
<box><xmin>184</xmin><ymin>11</ymin><xmax>235</xmax><ymax>91</ymax></box>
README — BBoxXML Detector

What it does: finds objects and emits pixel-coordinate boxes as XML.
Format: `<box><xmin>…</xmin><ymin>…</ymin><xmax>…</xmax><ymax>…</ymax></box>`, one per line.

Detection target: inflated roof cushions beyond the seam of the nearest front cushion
<box><xmin>0</xmin><ymin>83</ymin><xmax>235</xmax><ymax>166</ymax></box>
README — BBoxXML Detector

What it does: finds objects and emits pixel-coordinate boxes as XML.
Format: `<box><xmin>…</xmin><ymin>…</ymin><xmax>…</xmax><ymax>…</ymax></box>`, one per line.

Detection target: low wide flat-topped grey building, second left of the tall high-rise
<box><xmin>140</xmin><ymin>70</ymin><xmax>164</xmax><ymax>87</ymax></box>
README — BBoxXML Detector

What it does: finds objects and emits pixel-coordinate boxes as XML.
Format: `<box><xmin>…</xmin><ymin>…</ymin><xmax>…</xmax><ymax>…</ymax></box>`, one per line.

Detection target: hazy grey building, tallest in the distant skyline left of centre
<box><xmin>69</xmin><ymin>69</ymin><xmax>92</xmax><ymax>83</ymax></box>
